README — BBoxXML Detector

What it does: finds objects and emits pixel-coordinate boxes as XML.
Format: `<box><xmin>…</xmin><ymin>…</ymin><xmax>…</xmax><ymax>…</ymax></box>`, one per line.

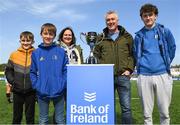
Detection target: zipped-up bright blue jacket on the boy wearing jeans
<box><xmin>30</xmin><ymin>43</ymin><xmax>68</xmax><ymax>99</ymax></box>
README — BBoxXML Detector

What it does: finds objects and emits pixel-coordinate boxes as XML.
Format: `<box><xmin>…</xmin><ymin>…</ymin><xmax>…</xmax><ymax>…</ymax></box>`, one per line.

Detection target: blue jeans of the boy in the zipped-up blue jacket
<box><xmin>38</xmin><ymin>96</ymin><xmax>65</xmax><ymax>124</ymax></box>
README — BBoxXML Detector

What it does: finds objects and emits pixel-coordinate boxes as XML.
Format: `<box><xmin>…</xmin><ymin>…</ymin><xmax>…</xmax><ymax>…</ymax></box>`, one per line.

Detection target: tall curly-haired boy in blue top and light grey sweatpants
<box><xmin>134</xmin><ymin>4</ymin><xmax>176</xmax><ymax>125</ymax></box>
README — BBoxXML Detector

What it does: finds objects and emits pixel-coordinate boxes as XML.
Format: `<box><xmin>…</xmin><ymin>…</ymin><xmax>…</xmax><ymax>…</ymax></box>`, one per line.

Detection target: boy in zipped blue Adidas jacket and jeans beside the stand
<box><xmin>30</xmin><ymin>23</ymin><xmax>68</xmax><ymax>124</ymax></box>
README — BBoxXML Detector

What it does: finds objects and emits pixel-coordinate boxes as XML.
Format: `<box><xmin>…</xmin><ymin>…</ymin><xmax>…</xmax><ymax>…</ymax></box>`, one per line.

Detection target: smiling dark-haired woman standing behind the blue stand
<box><xmin>58</xmin><ymin>27</ymin><xmax>83</xmax><ymax>64</ymax></box>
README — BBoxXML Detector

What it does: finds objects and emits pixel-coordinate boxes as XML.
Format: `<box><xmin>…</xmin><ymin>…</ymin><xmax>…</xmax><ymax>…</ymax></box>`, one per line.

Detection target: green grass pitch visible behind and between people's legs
<box><xmin>0</xmin><ymin>81</ymin><xmax>180</xmax><ymax>124</ymax></box>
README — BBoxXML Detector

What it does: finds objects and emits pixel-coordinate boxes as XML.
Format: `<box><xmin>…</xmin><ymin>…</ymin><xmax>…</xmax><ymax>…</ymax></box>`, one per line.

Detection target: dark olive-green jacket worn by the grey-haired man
<box><xmin>94</xmin><ymin>26</ymin><xmax>134</xmax><ymax>76</ymax></box>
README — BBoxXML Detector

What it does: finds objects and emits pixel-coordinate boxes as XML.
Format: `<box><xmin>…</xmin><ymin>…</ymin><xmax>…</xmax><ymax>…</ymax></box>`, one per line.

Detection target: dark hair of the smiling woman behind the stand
<box><xmin>57</xmin><ymin>27</ymin><xmax>76</xmax><ymax>44</ymax></box>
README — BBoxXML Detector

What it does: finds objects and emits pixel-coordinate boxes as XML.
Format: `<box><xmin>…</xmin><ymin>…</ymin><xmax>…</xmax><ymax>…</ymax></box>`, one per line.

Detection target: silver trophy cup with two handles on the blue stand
<box><xmin>80</xmin><ymin>32</ymin><xmax>104</xmax><ymax>64</ymax></box>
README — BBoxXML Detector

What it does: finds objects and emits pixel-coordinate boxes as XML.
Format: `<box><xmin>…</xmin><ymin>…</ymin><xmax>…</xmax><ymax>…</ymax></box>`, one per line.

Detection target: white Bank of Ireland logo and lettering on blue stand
<box><xmin>70</xmin><ymin>92</ymin><xmax>110</xmax><ymax>125</ymax></box>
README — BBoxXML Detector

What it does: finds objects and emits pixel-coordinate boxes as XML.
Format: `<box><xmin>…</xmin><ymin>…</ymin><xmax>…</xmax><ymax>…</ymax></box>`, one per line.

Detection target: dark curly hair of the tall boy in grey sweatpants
<box><xmin>140</xmin><ymin>3</ymin><xmax>158</xmax><ymax>17</ymax></box>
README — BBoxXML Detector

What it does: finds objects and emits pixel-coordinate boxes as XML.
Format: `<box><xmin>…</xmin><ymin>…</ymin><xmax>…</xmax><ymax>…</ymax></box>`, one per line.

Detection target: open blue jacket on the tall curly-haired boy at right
<box><xmin>133</xmin><ymin>23</ymin><xmax>176</xmax><ymax>74</ymax></box>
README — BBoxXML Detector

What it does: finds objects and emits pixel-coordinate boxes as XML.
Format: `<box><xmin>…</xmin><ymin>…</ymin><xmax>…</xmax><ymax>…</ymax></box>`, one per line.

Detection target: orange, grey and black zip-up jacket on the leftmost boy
<box><xmin>5</xmin><ymin>47</ymin><xmax>34</xmax><ymax>93</ymax></box>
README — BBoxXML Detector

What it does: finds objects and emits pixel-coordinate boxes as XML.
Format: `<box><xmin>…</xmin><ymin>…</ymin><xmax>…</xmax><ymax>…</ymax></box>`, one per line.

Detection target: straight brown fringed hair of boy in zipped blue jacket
<box><xmin>40</xmin><ymin>23</ymin><xmax>57</xmax><ymax>37</ymax></box>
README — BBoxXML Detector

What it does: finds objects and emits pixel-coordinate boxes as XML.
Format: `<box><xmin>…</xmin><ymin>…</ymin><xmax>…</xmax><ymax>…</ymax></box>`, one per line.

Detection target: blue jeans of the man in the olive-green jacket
<box><xmin>115</xmin><ymin>76</ymin><xmax>132</xmax><ymax>124</ymax></box>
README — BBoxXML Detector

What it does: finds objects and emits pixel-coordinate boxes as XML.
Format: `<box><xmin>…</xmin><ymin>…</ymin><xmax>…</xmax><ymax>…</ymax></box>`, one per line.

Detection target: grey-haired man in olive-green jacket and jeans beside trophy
<box><xmin>94</xmin><ymin>11</ymin><xmax>134</xmax><ymax>124</ymax></box>
